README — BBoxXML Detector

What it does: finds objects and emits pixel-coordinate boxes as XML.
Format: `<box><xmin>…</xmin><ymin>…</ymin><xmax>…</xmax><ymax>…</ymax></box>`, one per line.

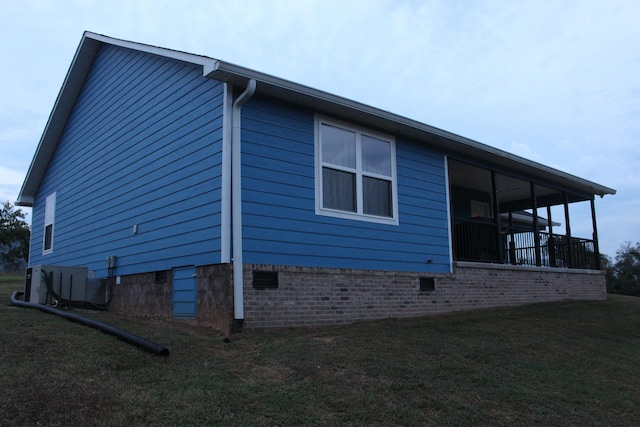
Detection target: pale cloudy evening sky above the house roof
<box><xmin>0</xmin><ymin>0</ymin><xmax>640</xmax><ymax>257</ymax></box>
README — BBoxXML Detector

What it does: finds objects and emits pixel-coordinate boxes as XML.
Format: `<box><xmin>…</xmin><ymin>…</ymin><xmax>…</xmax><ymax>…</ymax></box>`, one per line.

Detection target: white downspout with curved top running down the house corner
<box><xmin>231</xmin><ymin>79</ymin><xmax>256</xmax><ymax>329</ymax></box>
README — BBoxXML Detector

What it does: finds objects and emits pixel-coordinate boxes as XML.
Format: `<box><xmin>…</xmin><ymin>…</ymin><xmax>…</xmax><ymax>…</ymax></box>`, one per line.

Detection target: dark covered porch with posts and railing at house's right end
<box><xmin>448</xmin><ymin>159</ymin><xmax>603</xmax><ymax>270</ymax></box>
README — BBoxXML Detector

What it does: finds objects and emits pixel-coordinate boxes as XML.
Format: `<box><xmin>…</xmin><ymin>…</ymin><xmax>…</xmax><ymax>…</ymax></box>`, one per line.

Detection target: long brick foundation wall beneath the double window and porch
<box><xmin>244</xmin><ymin>263</ymin><xmax>606</xmax><ymax>328</ymax></box>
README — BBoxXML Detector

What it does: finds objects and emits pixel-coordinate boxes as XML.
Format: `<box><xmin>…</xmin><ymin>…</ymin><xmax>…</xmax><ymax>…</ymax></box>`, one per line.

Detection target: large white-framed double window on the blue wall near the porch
<box><xmin>316</xmin><ymin>117</ymin><xmax>398</xmax><ymax>225</ymax></box>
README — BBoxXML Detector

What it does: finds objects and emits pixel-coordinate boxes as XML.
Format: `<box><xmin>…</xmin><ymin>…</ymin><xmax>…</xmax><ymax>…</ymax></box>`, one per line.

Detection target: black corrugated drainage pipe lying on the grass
<box><xmin>11</xmin><ymin>291</ymin><xmax>169</xmax><ymax>356</ymax></box>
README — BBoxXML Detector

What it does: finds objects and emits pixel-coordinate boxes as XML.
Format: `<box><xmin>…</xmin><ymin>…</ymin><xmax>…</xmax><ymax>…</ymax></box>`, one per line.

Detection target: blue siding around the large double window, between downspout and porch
<box><xmin>242</xmin><ymin>96</ymin><xmax>450</xmax><ymax>272</ymax></box>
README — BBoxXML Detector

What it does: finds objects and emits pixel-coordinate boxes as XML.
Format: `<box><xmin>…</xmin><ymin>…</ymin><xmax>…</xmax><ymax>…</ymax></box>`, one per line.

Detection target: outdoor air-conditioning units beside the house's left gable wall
<box><xmin>25</xmin><ymin>265</ymin><xmax>89</xmax><ymax>304</ymax></box>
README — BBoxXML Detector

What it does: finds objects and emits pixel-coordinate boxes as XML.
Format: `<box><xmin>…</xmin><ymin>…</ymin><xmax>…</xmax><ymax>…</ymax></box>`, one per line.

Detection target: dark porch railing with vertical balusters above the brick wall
<box><xmin>453</xmin><ymin>220</ymin><xmax>596</xmax><ymax>269</ymax></box>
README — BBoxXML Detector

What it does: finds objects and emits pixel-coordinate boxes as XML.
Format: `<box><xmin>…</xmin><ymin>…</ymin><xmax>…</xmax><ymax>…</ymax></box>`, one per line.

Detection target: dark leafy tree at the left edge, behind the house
<box><xmin>0</xmin><ymin>201</ymin><xmax>31</xmax><ymax>270</ymax></box>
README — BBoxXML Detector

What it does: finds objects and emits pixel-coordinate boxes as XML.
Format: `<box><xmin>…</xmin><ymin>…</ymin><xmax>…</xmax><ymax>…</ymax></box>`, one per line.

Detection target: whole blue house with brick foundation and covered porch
<box><xmin>17</xmin><ymin>32</ymin><xmax>615</xmax><ymax>333</ymax></box>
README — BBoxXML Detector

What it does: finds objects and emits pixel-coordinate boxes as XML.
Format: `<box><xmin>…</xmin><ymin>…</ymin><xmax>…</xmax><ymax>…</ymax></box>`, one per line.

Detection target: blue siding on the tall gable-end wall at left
<box><xmin>30</xmin><ymin>45</ymin><xmax>223</xmax><ymax>277</ymax></box>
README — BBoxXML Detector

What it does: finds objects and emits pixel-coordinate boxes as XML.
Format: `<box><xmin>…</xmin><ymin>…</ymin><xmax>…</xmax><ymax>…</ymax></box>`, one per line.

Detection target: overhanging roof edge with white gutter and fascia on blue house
<box><xmin>16</xmin><ymin>32</ymin><xmax>616</xmax><ymax>206</ymax></box>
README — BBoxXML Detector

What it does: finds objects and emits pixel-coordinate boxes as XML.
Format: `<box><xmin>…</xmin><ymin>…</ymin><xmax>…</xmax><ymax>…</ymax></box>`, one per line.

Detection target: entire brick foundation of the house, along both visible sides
<box><xmin>110</xmin><ymin>262</ymin><xmax>606</xmax><ymax>335</ymax></box>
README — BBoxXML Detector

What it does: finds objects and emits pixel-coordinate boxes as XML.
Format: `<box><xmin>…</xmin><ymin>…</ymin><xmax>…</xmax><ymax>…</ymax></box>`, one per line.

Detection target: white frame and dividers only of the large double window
<box><xmin>314</xmin><ymin>115</ymin><xmax>399</xmax><ymax>225</ymax></box>
